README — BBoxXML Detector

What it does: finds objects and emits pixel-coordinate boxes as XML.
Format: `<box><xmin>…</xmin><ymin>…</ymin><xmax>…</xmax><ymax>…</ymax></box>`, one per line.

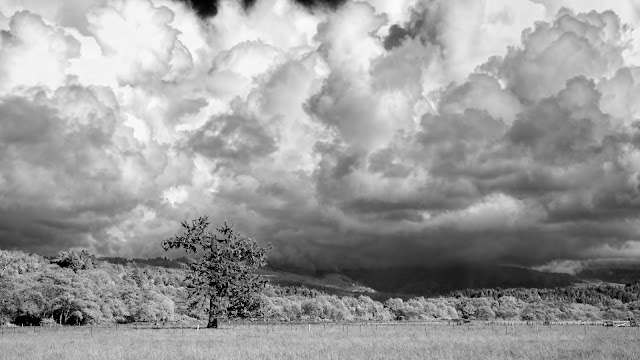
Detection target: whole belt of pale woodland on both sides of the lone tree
<box><xmin>0</xmin><ymin>251</ymin><xmax>640</xmax><ymax>325</ymax></box>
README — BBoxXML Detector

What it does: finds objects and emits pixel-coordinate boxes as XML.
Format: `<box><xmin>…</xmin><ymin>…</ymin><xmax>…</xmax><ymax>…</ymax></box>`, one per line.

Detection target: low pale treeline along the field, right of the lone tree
<box><xmin>263</xmin><ymin>294</ymin><xmax>640</xmax><ymax>321</ymax></box>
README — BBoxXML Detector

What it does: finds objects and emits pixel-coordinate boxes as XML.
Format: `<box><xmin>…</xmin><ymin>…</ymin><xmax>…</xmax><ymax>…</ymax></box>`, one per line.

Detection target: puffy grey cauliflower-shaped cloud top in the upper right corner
<box><xmin>483</xmin><ymin>10</ymin><xmax>625</xmax><ymax>102</ymax></box>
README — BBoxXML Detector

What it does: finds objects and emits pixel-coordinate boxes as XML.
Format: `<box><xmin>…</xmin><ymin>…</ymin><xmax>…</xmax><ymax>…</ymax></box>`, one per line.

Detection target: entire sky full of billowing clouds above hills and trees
<box><xmin>0</xmin><ymin>0</ymin><xmax>640</xmax><ymax>273</ymax></box>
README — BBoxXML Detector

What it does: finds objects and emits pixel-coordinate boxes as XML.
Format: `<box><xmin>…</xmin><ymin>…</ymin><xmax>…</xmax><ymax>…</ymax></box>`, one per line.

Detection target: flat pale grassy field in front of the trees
<box><xmin>0</xmin><ymin>324</ymin><xmax>640</xmax><ymax>360</ymax></box>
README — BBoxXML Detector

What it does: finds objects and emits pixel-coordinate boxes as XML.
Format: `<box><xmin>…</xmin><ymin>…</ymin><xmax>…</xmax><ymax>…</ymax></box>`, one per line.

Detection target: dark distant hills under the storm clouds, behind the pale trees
<box><xmin>98</xmin><ymin>257</ymin><xmax>640</xmax><ymax>301</ymax></box>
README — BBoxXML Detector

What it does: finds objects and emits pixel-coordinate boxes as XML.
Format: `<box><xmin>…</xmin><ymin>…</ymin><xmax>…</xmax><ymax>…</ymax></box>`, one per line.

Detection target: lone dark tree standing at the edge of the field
<box><xmin>162</xmin><ymin>216</ymin><xmax>271</xmax><ymax>328</ymax></box>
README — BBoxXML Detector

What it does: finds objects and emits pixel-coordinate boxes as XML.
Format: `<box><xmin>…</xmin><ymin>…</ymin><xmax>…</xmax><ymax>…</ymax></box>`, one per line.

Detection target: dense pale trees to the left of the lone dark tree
<box><xmin>0</xmin><ymin>251</ymin><xmax>190</xmax><ymax>325</ymax></box>
